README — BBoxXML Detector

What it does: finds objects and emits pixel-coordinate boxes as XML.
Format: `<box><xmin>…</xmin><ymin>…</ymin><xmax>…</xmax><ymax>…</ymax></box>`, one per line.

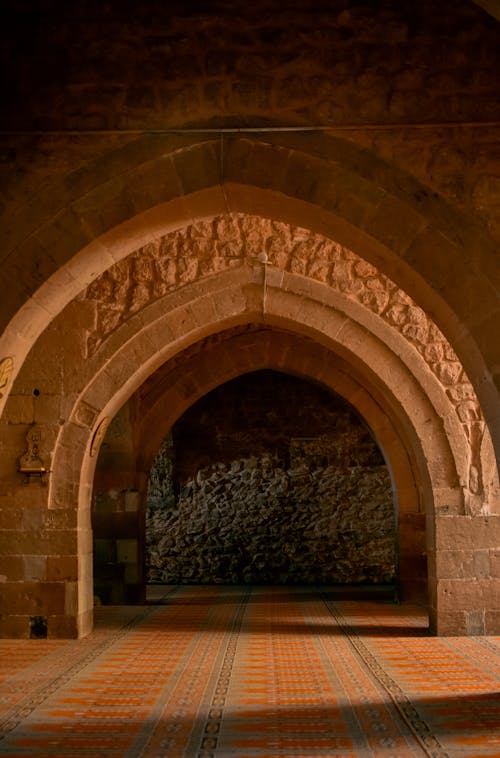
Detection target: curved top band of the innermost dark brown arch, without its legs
<box><xmin>133</xmin><ymin>330</ymin><xmax>421</xmax><ymax>496</ymax></box>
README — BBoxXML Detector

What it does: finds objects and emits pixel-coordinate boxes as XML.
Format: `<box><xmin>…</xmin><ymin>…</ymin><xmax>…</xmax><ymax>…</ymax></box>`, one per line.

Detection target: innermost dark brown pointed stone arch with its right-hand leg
<box><xmin>129</xmin><ymin>324</ymin><xmax>422</xmax><ymax>602</ymax></box>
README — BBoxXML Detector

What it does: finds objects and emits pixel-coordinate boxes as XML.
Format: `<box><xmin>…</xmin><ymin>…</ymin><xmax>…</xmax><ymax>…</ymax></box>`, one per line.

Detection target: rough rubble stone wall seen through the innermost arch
<box><xmin>146</xmin><ymin>371</ymin><xmax>395</xmax><ymax>584</ymax></box>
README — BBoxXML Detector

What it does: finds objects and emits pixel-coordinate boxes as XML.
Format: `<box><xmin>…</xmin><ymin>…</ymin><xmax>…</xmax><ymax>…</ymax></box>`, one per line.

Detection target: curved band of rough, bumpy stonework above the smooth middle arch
<box><xmin>85</xmin><ymin>214</ymin><xmax>483</xmax><ymax>510</ymax></box>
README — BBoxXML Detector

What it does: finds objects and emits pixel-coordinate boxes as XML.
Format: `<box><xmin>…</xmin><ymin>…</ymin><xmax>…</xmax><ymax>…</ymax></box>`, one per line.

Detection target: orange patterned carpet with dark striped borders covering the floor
<box><xmin>0</xmin><ymin>587</ymin><xmax>500</xmax><ymax>758</ymax></box>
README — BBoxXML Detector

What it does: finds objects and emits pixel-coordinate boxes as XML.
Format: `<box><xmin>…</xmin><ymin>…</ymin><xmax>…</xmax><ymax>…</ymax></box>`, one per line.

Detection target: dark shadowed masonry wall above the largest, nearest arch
<box><xmin>0</xmin><ymin>0</ymin><xmax>500</xmax><ymax>243</ymax></box>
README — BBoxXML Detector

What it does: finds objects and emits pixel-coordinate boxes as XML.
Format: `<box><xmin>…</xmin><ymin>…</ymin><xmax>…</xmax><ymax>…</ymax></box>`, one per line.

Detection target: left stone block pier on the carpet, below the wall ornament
<box><xmin>0</xmin><ymin>482</ymin><xmax>88</xmax><ymax>638</ymax></box>
